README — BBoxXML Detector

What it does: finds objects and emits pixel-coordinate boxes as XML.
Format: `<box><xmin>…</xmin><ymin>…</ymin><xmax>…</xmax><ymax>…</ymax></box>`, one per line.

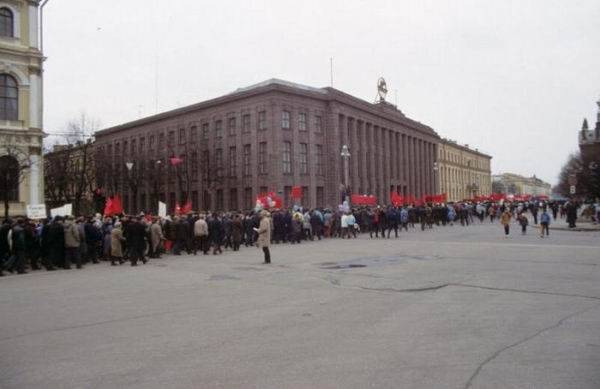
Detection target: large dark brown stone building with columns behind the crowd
<box><xmin>95</xmin><ymin>79</ymin><xmax>440</xmax><ymax>212</ymax></box>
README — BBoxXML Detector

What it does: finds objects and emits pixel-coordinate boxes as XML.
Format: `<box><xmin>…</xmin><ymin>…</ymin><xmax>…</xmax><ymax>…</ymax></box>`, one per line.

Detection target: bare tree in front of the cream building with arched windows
<box><xmin>0</xmin><ymin>145</ymin><xmax>32</xmax><ymax>218</ymax></box>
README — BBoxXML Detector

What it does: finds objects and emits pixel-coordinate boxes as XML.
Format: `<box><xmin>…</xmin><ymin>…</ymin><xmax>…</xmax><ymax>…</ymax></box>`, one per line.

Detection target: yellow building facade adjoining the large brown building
<box><xmin>438</xmin><ymin>139</ymin><xmax>492</xmax><ymax>201</ymax></box>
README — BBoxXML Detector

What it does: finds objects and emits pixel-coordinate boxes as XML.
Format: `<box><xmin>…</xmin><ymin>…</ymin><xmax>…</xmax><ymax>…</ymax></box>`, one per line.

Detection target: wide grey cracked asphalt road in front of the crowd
<box><xmin>0</xmin><ymin>220</ymin><xmax>600</xmax><ymax>389</ymax></box>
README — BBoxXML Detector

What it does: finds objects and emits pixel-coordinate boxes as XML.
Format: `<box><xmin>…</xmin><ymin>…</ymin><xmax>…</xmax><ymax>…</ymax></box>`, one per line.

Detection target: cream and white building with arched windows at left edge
<box><xmin>0</xmin><ymin>0</ymin><xmax>44</xmax><ymax>215</ymax></box>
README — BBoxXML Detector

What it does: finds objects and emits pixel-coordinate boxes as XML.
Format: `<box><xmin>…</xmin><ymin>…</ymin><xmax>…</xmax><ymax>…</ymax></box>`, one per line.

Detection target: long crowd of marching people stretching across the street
<box><xmin>0</xmin><ymin>202</ymin><xmax>600</xmax><ymax>275</ymax></box>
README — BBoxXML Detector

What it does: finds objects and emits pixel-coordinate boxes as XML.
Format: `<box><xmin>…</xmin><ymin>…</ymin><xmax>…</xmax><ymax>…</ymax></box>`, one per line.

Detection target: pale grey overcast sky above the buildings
<box><xmin>44</xmin><ymin>0</ymin><xmax>600</xmax><ymax>183</ymax></box>
